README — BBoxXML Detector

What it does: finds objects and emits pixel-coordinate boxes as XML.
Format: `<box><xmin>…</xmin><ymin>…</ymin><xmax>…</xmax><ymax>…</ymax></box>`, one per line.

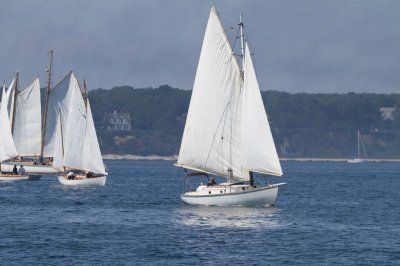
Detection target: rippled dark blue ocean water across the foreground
<box><xmin>0</xmin><ymin>161</ymin><xmax>400</xmax><ymax>265</ymax></box>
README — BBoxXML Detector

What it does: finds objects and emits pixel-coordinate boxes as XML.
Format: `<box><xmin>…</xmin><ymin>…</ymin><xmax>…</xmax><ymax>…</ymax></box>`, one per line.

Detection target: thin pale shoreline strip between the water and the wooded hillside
<box><xmin>103</xmin><ymin>154</ymin><xmax>400</xmax><ymax>163</ymax></box>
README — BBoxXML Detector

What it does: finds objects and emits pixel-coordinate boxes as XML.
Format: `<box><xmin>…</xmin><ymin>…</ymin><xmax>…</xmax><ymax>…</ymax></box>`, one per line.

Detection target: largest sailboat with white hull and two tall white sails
<box><xmin>175</xmin><ymin>6</ymin><xmax>286</xmax><ymax>206</ymax></box>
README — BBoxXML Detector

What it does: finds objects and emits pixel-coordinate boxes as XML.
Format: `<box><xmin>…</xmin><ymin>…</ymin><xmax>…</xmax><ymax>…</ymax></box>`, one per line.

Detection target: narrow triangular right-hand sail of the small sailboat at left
<box><xmin>82</xmin><ymin>99</ymin><xmax>106</xmax><ymax>174</ymax></box>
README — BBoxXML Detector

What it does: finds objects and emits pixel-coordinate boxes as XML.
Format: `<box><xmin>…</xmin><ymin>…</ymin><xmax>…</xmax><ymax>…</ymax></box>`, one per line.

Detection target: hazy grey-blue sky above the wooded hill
<box><xmin>0</xmin><ymin>0</ymin><xmax>400</xmax><ymax>93</ymax></box>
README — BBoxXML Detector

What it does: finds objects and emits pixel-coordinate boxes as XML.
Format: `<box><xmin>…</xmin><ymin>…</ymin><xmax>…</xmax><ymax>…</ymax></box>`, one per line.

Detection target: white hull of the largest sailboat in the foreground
<box><xmin>181</xmin><ymin>183</ymin><xmax>286</xmax><ymax>206</ymax></box>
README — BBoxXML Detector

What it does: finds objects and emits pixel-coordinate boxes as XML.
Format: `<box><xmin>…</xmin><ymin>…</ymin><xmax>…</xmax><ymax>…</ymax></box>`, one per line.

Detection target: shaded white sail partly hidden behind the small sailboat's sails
<box><xmin>43</xmin><ymin>72</ymin><xmax>80</xmax><ymax>157</ymax></box>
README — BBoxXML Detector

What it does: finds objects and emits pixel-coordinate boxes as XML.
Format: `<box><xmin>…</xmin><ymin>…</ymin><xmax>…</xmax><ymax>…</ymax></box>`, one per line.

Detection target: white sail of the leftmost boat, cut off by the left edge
<box><xmin>0</xmin><ymin>80</ymin><xmax>18</xmax><ymax>162</ymax></box>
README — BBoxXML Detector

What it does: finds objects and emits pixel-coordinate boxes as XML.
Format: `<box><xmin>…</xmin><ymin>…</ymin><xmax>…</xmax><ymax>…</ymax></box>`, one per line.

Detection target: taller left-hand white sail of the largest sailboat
<box><xmin>177</xmin><ymin>7</ymin><xmax>243</xmax><ymax>179</ymax></box>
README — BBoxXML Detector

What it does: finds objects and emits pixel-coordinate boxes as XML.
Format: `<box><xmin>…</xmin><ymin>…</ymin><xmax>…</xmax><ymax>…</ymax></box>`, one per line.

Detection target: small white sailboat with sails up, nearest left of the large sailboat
<box><xmin>52</xmin><ymin>72</ymin><xmax>107</xmax><ymax>186</ymax></box>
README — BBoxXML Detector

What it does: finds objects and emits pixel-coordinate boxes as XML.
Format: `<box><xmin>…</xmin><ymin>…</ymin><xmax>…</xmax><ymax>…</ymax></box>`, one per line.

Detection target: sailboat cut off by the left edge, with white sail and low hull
<box><xmin>0</xmin><ymin>80</ymin><xmax>29</xmax><ymax>181</ymax></box>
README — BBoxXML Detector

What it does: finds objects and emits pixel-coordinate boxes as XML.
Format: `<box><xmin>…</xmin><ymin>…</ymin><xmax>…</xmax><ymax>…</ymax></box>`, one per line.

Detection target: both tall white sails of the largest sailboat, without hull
<box><xmin>177</xmin><ymin>7</ymin><xmax>282</xmax><ymax>180</ymax></box>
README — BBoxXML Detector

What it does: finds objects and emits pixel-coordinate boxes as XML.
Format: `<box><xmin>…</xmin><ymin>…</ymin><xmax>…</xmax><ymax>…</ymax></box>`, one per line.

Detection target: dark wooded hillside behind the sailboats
<box><xmin>89</xmin><ymin>85</ymin><xmax>400</xmax><ymax>158</ymax></box>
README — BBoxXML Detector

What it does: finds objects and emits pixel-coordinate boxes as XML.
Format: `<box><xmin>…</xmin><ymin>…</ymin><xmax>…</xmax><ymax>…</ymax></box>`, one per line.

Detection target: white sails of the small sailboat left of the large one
<box><xmin>47</xmin><ymin>73</ymin><xmax>106</xmax><ymax>174</ymax></box>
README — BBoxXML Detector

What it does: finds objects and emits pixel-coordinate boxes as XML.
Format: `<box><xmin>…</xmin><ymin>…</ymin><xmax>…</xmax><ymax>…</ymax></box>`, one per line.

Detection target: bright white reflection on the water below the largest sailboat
<box><xmin>176</xmin><ymin>205</ymin><xmax>283</xmax><ymax>229</ymax></box>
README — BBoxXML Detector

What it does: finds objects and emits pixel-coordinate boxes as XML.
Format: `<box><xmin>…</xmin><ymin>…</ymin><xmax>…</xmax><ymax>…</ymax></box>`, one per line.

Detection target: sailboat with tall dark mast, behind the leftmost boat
<box><xmin>3</xmin><ymin>50</ymin><xmax>58</xmax><ymax>174</ymax></box>
